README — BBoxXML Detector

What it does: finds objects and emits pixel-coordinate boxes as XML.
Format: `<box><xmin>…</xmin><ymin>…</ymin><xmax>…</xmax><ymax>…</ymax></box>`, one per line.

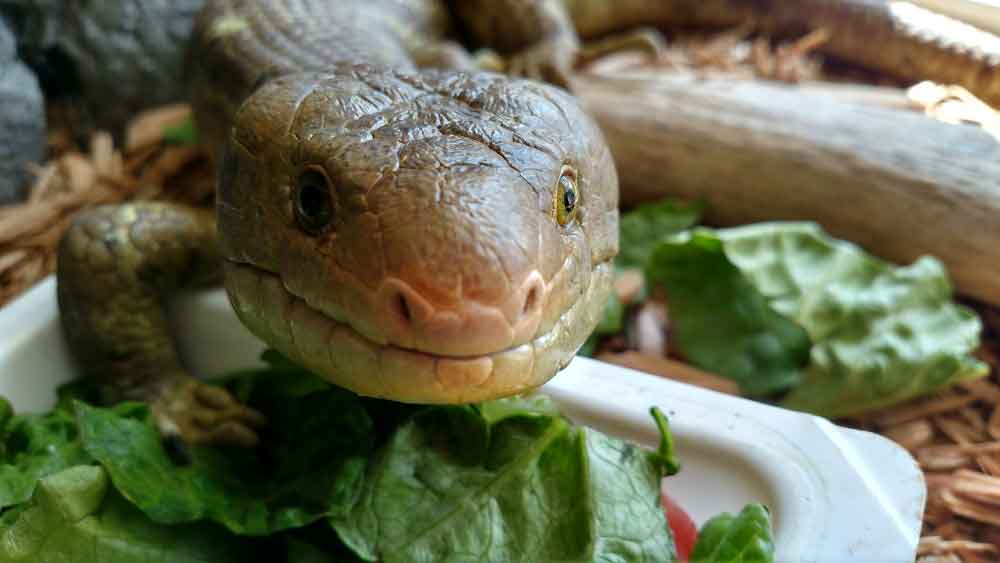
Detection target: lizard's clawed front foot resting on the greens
<box><xmin>152</xmin><ymin>377</ymin><xmax>266</xmax><ymax>457</ymax></box>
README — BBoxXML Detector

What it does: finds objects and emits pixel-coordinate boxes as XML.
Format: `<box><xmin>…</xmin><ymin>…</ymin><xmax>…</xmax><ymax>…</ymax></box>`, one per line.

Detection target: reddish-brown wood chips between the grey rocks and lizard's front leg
<box><xmin>0</xmin><ymin>105</ymin><xmax>214</xmax><ymax>306</ymax></box>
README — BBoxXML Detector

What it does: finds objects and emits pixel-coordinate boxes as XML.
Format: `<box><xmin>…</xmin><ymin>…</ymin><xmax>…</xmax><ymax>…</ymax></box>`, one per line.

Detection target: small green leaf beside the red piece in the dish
<box><xmin>690</xmin><ymin>504</ymin><xmax>774</xmax><ymax>563</ymax></box>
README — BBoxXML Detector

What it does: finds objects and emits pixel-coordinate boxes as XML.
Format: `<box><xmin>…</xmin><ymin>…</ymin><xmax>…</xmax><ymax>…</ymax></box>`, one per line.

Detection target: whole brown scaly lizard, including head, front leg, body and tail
<box><xmin>58</xmin><ymin>0</ymin><xmax>997</xmax><ymax>445</ymax></box>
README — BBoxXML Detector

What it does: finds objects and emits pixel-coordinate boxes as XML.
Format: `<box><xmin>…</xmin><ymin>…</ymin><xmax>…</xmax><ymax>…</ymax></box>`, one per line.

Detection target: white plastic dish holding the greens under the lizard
<box><xmin>0</xmin><ymin>278</ymin><xmax>926</xmax><ymax>563</ymax></box>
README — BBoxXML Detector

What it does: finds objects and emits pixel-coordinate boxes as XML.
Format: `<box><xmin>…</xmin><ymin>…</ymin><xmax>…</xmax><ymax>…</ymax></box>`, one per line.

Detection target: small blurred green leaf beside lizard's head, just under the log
<box><xmin>615</xmin><ymin>199</ymin><xmax>705</xmax><ymax>268</ymax></box>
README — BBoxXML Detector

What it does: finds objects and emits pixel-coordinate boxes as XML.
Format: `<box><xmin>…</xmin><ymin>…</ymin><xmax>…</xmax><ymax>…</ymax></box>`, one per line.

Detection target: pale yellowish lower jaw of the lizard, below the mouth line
<box><xmin>225</xmin><ymin>260</ymin><xmax>613</xmax><ymax>404</ymax></box>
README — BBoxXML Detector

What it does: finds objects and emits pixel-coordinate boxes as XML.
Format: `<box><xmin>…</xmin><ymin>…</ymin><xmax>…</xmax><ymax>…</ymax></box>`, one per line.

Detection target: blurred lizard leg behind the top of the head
<box><xmin>449</xmin><ymin>0</ymin><xmax>580</xmax><ymax>89</ymax></box>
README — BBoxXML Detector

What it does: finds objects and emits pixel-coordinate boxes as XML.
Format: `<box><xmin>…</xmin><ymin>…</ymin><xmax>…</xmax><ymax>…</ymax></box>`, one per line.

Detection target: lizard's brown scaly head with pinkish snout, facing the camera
<box><xmin>218</xmin><ymin>65</ymin><xmax>618</xmax><ymax>403</ymax></box>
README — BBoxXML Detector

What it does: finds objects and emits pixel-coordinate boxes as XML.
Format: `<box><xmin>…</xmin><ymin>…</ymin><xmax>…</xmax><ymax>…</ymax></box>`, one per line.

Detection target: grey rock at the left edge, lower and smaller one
<box><xmin>0</xmin><ymin>14</ymin><xmax>45</xmax><ymax>205</ymax></box>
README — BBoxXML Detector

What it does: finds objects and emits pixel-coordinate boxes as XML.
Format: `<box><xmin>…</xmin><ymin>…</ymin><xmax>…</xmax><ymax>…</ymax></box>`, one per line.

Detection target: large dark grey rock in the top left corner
<box><xmin>4</xmin><ymin>0</ymin><xmax>204</xmax><ymax>135</ymax></box>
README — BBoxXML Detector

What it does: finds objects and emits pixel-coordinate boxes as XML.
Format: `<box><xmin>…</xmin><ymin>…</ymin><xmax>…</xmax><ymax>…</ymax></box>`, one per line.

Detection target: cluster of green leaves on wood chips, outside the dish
<box><xmin>612</xmin><ymin>196</ymin><xmax>988</xmax><ymax>417</ymax></box>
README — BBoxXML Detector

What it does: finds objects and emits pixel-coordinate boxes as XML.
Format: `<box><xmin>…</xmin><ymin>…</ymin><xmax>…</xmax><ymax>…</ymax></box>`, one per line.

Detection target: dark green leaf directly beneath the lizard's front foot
<box><xmin>75</xmin><ymin>375</ymin><xmax>373</xmax><ymax>535</ymax></box>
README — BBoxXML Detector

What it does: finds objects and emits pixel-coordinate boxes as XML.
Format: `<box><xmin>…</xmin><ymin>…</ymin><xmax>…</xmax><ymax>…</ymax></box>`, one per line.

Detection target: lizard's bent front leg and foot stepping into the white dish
<box><xmin>56</xmin><ymin>202</ymin><xmax>264</xmax><ymax>447</ymax></box>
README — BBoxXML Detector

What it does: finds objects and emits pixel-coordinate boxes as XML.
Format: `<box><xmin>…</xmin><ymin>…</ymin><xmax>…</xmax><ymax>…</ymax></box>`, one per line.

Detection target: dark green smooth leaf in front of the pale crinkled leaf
<box><xmin>646</xmin><ymin>229</ymin><xmax>810</xmax><ymax>396</ymax></box>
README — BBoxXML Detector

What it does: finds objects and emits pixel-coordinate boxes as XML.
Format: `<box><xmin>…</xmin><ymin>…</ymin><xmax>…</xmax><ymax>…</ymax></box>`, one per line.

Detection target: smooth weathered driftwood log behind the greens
<box><xmin>574</xmin><ymin>75</ymin><xmax>1000</xmax><ymax>304</ymax></box>
